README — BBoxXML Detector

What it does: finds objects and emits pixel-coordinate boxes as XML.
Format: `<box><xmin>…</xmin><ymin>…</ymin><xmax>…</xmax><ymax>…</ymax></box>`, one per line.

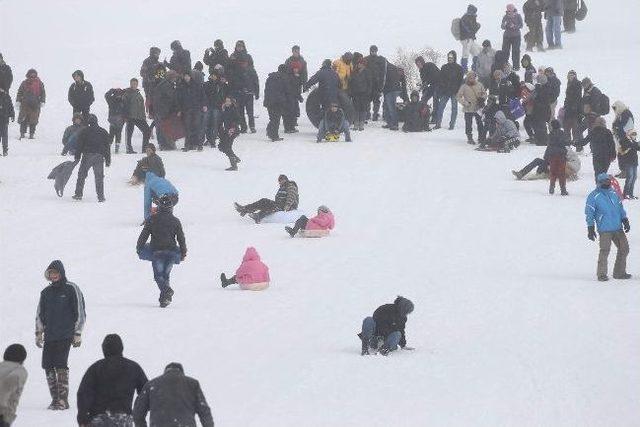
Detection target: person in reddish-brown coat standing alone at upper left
<box><xmin>16</xmin><ymin>68</ymin><xmax>46</xmax><ymax>139</ymax></box>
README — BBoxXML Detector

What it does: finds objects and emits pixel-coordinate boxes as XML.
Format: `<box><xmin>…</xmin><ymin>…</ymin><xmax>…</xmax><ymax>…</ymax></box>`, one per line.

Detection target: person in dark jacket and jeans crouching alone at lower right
<box><xmin>358</xmin><ymin>296</ymin><xmax>413</xmax><ymax>356</ymax></box>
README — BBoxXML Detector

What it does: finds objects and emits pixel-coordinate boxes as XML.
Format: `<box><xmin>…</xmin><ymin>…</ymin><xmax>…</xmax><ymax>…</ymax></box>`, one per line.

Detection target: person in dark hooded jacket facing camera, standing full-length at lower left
<box><xmin>36</xmin><ymin>260</ymin><xmax>87</xmax><ymax>410</ymax></box>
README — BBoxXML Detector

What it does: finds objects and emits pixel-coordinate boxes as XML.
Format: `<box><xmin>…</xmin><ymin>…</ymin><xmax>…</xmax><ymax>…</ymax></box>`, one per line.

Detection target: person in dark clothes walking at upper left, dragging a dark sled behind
<box><xmin>72</xmin><ymin>114</ymin><xmax>111</xmax><ymax>202</ymax></box>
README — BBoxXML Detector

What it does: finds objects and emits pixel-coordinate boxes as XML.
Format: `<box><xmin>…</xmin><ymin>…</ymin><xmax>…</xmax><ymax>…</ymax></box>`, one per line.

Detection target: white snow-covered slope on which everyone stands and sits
<box><xmin>0</xmin><ymin>0</ymin><xmax>640</xmax><ymax>427</ymax></box>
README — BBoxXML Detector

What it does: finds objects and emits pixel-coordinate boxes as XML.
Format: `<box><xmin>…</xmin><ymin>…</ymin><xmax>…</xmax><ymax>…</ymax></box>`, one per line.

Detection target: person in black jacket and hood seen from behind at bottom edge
<box><xmin>77</xmin><ymin>334</ymin><xmax>148</xmax><ymax>426</ymax></box>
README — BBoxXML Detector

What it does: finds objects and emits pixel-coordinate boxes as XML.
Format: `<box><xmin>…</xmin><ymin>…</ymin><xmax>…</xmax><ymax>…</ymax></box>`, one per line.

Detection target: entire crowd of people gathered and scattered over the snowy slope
<box><xmin>0</xmin><ymin>0</ymin><xmax>640</xmax><ymax>427</ymax></box>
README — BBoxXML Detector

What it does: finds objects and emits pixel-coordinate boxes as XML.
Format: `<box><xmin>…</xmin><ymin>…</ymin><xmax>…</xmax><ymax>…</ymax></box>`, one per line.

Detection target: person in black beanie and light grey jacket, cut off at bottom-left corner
<box><xmin>0</xmin><ymin>344</ymin><xmax>28</xmax><ymax>427</ymax></box>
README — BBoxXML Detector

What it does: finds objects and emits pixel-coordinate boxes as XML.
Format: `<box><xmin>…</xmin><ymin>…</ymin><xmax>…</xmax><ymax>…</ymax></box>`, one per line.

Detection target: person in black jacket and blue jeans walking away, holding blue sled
<box><xmin>136</xmin><ymin>194</ymin><xmax>187</xmax><ymax>308</ymax></box>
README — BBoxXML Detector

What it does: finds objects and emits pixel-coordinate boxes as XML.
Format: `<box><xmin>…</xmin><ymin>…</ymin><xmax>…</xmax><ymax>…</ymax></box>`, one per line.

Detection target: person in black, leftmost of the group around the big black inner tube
<box><xmin>262</xmin><ymin>64</ymin><xmax>291</xmax><ymax>142</ymax></box>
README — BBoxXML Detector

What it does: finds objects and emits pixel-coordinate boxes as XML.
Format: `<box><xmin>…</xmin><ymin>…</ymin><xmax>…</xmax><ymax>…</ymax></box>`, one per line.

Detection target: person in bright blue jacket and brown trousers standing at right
<box><xmin>584</xmin><ymin>173</ymin><xmax>631</xmax><ymax>282</ymax></box>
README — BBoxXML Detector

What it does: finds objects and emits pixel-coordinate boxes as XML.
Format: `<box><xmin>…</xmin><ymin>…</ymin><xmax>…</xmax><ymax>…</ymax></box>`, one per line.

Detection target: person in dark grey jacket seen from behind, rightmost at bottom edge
<box><xmin>133</xmin><ymin>362</ymin><xmax>214</xmax><ymax>427</ymax></box>
